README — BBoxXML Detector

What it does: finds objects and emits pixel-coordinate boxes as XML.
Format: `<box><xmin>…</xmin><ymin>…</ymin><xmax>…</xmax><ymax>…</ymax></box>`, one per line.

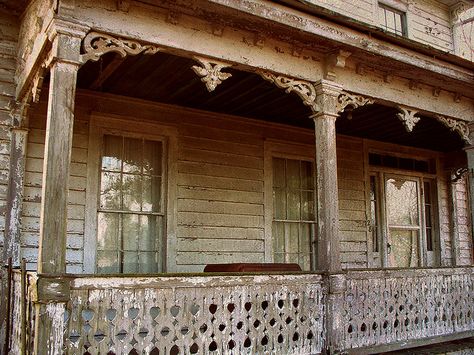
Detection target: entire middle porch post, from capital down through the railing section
<box><xmin>312</xmin><ymin>80</ymin><xmax>346</xmax><ymax>354</ymax></box>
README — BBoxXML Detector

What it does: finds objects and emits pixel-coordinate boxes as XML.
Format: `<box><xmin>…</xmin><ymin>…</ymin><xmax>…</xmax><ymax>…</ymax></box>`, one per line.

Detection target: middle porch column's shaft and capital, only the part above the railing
<box><xmin>312</xmin><ymin>80</ymin><xmax>341</xmax><ymax>272</ymax></box>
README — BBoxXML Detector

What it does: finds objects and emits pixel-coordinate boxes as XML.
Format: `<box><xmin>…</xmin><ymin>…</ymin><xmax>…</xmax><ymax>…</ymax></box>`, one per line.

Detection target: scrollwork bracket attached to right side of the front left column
<box><xmin>81</xmin><ymin>32</ymin><xmax>160</xmax><ymax>63</ymax></box>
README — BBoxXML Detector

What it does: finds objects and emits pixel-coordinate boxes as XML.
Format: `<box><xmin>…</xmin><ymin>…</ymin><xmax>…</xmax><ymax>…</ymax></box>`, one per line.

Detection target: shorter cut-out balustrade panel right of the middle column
<box><xmin>341</xmin><ymin>268</ymin><xmax>474</xmax><ymax>349</ymax></box>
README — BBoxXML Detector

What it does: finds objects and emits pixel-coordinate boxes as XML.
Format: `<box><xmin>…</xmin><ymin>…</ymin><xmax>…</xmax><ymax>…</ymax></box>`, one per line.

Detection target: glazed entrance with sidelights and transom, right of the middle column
<box><xmin>369</xmin><ymin>154</ymin><xmax>438</xmax><ymax>267</ymax></box>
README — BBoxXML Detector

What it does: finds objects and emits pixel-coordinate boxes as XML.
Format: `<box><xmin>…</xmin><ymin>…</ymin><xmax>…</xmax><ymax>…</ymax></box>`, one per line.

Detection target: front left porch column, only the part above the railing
<box><xmin>38</xmin><ymin>33</ymin><xmax>81</xmax><ymax>274</ymax></box>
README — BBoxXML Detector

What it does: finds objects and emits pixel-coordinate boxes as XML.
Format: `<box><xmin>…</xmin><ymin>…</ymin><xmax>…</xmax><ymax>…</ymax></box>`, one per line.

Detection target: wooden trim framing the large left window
<box><xmin>83</xmin><ymin>113</ymin><xmax>177</xmax><ymax>274</ymax></box>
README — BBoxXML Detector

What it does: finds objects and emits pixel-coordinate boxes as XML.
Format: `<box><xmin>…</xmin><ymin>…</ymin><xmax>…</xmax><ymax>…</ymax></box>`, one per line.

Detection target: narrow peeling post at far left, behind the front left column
<box><xmin>3</xmin><ymin>102</ymin><xmax>29</xmax><ymax>267</ymax></box>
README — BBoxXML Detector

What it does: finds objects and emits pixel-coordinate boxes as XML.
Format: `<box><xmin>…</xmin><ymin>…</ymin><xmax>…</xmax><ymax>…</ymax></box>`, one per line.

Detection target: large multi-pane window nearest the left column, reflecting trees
<box><xmin>96</xmin><ymin>135</ymin><xmax>165</xmax><ymax>273</ymax></box>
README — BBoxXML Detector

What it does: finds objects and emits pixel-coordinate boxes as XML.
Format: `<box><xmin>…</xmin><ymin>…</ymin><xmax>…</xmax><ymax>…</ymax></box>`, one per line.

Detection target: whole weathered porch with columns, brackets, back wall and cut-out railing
<box><xmin>0</xmin><ymin>8</ymin><xmax>474</xmax><ymax>354</ymax></box>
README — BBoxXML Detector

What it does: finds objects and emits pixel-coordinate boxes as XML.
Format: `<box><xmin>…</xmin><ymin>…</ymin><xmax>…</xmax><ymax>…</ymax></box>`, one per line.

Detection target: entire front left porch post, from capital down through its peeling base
<box><xmin>35</xmin><ymin>22</ymin><xmax>85</xmax><ymax>355</ymax></box>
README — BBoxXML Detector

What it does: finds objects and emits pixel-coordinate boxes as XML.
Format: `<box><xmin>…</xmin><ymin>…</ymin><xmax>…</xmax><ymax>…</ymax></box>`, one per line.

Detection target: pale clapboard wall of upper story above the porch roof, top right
<box><xmin>298</xmin><ymin>0</ymin><xmax>472</xmax><ymax>56</ymax></box>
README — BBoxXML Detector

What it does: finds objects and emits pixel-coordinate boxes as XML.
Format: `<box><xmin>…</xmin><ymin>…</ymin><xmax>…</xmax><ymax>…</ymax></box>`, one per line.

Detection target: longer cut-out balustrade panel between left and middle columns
<box><xmin>65</xmin><ymin>274</ymin><xmax>324</xmax><ymax>355</ymax></box>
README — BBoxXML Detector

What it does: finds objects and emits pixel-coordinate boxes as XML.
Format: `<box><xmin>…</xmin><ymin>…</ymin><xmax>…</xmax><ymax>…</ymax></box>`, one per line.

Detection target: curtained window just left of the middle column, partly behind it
<box><xmin>272</xmin><ymin>157</ymin><xmax>315</xmax><ymax>270</ymax></box>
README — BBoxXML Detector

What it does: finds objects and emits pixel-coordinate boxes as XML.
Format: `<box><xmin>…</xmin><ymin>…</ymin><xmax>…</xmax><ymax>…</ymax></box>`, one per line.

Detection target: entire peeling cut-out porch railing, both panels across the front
<box><xmin>2</xmin><ymin>267</ymin><xmax>474</xmax><ymax>354</ymax></box>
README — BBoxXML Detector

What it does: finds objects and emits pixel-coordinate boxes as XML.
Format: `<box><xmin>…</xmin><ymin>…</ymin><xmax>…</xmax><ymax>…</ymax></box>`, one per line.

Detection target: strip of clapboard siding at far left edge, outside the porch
<box><xmin>0</xmin><ymin>10</ymin><xmax>19</xmax><ymax>262</ymax></box>
